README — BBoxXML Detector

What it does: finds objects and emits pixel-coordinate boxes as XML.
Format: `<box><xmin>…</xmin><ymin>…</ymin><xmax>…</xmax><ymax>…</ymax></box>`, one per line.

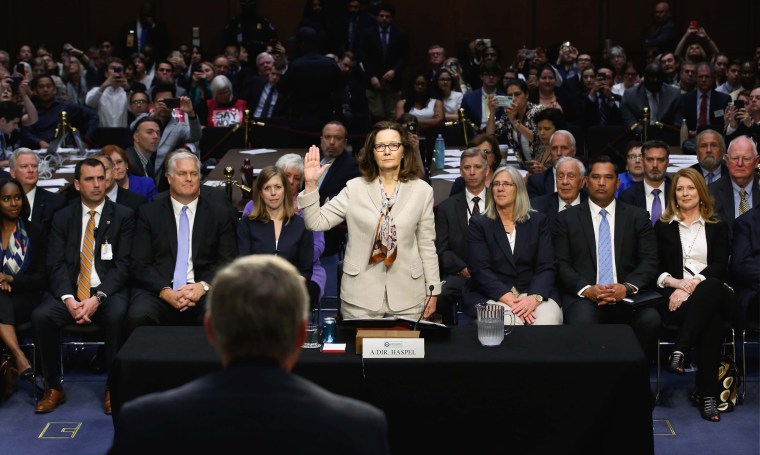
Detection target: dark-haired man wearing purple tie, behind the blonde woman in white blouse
<box><xmin>618</xmin><ymin>140</ymin><xmax>670</xmax><ymax>225</ymax></box>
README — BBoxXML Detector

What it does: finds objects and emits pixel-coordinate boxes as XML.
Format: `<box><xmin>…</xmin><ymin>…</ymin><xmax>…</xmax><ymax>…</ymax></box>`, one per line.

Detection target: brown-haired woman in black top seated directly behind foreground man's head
<box><xmin>237</xmin><ymin>166</ymin><xmax>314</xmax><ymax>283</ymax></box>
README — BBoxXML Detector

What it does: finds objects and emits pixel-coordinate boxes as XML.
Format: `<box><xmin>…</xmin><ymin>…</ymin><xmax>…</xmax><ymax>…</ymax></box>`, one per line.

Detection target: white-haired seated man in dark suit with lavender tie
<box><xmin>126</xmin><ymin>149</ymin><xmax>237</xmax><ymax>334</ymax></box>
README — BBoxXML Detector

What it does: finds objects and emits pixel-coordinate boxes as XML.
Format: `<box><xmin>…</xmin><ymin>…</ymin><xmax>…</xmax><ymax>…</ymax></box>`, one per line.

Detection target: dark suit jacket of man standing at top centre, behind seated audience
<box><xmin>359</xmin><ymin>25</ymin><xmax>409</xmax><ymax>90</ymax></box>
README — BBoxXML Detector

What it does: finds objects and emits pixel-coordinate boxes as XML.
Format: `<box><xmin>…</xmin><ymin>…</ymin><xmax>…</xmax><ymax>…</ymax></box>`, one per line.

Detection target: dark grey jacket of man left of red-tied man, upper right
<box><xmin>620</xmin><ymin>83</ymin><xmax>684</xmax><ymax>128</ymax></box>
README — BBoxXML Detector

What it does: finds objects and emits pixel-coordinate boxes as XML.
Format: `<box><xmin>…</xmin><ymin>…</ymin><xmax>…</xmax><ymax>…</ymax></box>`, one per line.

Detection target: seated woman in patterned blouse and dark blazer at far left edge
<box><xmin>0</xmin><ymin>179</ymin><xmax>47</xmax><ymax>388</ymax></box>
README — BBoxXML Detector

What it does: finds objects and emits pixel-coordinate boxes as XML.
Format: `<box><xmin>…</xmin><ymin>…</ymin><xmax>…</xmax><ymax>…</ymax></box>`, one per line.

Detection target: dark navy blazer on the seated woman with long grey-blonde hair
<box><xmin>462</xmin><ymin>212</ymin><xmax>556</xmax><ymax>316</ymax></box>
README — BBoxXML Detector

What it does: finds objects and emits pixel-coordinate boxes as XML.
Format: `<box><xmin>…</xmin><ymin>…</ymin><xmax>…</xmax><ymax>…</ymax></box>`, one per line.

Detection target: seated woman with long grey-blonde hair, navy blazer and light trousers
<box><xmin>462</xmin><ymin>166</ymin><xmax>562</xmax><ymax>325</ymax></box>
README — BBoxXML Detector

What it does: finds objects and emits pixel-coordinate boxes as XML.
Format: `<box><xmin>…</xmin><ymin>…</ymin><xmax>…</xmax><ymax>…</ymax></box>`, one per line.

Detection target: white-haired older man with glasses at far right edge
<box><xmin>708</xmin><ymin>136</ymin><xmax>760</xmax><ymax>235</ymax></box>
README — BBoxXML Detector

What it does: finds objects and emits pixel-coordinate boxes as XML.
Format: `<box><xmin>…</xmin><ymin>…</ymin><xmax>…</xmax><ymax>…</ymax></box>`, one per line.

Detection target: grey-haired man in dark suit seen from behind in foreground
<box><xmin>113</xmin><ymin>255</ymin><xmax>388</xmax><ymax>455</ymax></box>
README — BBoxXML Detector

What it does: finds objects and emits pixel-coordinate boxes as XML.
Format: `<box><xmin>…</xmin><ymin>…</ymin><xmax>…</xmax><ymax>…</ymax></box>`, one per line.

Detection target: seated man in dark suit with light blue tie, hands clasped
<box><xmin>553</xmin><ymin>155</ymin><xmax>662</xmax><ymax>354</ymax></box>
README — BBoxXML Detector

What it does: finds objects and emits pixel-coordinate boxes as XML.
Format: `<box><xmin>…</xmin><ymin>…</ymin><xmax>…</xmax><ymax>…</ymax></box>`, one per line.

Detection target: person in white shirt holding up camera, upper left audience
<box><xmin>85</xmin><ymin>57</ymin><xmax>129</xmax><ymax>128</ymax></box>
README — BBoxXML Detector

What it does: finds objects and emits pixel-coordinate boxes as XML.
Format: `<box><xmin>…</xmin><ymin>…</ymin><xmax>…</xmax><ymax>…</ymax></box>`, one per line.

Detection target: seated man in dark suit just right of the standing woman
<box><xmin>435</xmin><ymin>147</ymin><xmax>488</xmax><ymax>324</ymax></box>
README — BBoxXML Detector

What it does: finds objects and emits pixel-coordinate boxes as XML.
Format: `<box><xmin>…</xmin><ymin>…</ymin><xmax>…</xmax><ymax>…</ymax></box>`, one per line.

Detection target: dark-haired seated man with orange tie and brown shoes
<box><xmin>32</xmin><ymin>158</ymin><xmax>135</xmax><ymax>414</ymax></box>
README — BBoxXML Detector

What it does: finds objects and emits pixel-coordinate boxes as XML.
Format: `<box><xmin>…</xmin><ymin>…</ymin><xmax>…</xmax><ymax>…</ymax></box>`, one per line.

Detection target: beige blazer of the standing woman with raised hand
<box><xmin>298</xmin><ymin>177</ymin><xmax>441</xmax><ymax>311</ymax></box>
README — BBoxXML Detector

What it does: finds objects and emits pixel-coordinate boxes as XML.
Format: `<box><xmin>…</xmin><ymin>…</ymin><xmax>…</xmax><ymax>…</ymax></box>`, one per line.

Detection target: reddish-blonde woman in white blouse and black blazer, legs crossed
<box><xmin>655</xmin><ymin>168</ymin><xmax>733</xmax><ymax>422</ymax></box>
